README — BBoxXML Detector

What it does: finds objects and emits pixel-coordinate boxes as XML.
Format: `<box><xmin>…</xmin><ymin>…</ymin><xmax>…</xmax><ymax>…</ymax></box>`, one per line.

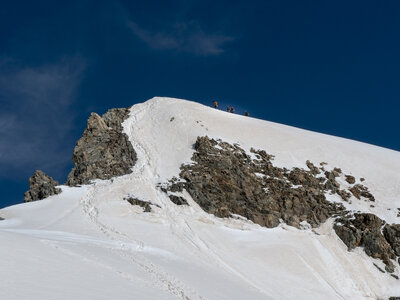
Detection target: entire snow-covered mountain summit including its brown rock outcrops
<box><xmin>0</xmin><ymin>97</ymin><xmax>400</xmax><ymax>299</ymax></box>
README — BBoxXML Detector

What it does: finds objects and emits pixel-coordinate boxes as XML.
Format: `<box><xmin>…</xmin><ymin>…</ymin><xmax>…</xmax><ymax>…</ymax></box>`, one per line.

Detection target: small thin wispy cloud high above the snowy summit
<box><xmin>127</xmin><ymin>20</ymin><xmax>234</xmax><ymax>56</ymax></box>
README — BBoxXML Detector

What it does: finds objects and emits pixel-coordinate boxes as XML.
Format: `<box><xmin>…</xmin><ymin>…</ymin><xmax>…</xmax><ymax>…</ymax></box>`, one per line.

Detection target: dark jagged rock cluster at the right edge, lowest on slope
<box><xmin>334</xmin><ymin>213</ymin><xmax>396</xmax><ymax>272</ymax></box>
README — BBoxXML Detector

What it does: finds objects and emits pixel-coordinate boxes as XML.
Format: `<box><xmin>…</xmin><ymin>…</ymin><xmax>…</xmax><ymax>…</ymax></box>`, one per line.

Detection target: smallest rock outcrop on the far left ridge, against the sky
<box><xmin>24</xmin><ymin>170</ymin><xmax>61</xmax><ymax>202</ymax></box>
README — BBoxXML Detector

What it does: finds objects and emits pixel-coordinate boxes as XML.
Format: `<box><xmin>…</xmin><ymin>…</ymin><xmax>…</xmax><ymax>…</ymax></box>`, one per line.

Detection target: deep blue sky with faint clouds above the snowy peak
<box><xmin>0</xmin><ymin>0</ymin><xmax>400</xmax><ymax>207</ymax></box>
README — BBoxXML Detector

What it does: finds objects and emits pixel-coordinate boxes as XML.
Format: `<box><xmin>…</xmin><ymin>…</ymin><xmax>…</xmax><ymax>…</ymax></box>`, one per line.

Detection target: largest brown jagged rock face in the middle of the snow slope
<box><xmin>168</xmin><ymin>137</ymin><xmax>344</xmax><ymax>228</ymax></box>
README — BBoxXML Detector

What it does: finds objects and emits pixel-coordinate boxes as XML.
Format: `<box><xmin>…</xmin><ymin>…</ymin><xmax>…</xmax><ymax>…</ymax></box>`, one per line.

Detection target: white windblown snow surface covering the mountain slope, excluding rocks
<box><xmin>0</xmin><ymin>97</ymin><xmax>400</xmax><ymax>300</ymax></box>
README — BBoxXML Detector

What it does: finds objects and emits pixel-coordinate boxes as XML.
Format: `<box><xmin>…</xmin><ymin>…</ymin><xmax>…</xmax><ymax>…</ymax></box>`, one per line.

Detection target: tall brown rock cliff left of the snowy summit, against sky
<box><xmin>67</xmin><ymin>108</ymin><xmax>137</xmax><ymax>186</ymax></box>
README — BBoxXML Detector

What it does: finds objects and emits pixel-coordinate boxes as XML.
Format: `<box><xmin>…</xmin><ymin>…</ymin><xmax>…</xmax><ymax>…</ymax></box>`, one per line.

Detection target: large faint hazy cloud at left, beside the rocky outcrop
<box><xmin>0</xmin><ymin>57</ymin><xmax>85</xmax><ymax>178</ymax></box>
